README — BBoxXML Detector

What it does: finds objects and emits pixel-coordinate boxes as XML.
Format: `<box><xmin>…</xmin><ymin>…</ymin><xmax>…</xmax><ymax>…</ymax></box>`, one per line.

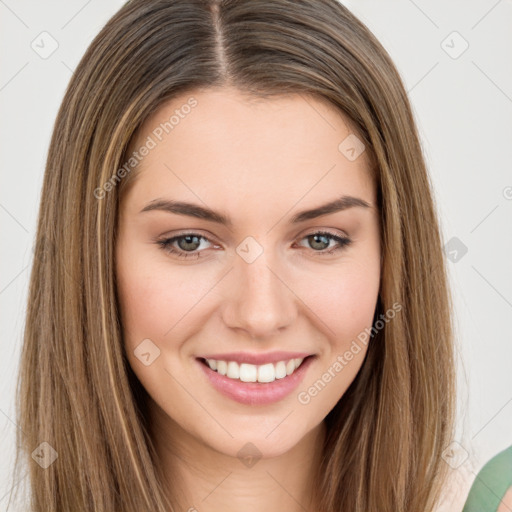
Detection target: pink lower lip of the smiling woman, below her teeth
<box><xmin>196</xmin><ymin>356</ymin><xmax>314</xmax><ymax>405</ymax></box>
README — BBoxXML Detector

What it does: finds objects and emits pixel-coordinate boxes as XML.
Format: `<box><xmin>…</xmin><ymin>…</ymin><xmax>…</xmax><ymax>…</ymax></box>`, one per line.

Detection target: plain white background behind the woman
<box><xmin>0</xmin><ymin>0</ymin><xmax>512</xmax><ymax>510</ymax></box>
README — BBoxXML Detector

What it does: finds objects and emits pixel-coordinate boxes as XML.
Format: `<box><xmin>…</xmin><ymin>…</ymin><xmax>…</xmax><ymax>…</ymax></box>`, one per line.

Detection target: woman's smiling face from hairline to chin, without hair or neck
<box><xmin>116</xmin><ymin>88</ymin><xmax>380</xmax><ymax>457</ymax></box>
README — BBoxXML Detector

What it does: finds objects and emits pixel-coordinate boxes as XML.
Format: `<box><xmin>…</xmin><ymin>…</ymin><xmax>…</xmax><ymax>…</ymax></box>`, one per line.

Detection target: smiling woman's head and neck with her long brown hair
<box><xmin>12</xmin><ymin>0</ymin><xmax>454</xmax><ymax>512</ymax></box>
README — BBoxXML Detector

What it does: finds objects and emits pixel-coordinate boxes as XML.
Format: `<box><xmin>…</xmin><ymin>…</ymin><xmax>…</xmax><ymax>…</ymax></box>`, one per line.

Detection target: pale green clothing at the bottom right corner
<box><xmin>462</xmin><ymin>446</ymin><xmax>512</xmax><ymax>512</ymax></box>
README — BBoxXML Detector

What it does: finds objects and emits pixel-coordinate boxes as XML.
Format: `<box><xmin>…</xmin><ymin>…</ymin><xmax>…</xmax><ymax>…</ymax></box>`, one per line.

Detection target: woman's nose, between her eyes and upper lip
<box><xmin>223</xmin><ymin>250</ymin><xmax>297</xmax><ymax>339</ymax></box>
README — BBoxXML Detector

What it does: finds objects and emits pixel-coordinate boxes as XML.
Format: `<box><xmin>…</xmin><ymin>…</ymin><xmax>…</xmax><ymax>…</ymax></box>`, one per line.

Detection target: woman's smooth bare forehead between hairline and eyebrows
<box><xmin>122</xmin><ymin>88</ymin><xmax>374</xmax><ymax>214</ymax></box>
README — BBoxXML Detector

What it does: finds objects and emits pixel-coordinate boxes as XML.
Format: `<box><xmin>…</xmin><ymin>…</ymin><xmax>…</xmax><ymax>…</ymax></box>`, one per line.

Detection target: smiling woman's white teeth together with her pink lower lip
<box><xmin>196</xmin><ymin>355</ymin><xmax>316</xmax><ymax>405</ymax></box>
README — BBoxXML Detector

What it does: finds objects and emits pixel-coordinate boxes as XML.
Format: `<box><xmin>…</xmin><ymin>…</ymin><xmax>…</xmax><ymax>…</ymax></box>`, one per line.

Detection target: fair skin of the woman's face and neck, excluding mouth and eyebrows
<box><xmin>116</xmin><ymin>88</ymin><xmax>381</xmax><ymax>512</ymax></box>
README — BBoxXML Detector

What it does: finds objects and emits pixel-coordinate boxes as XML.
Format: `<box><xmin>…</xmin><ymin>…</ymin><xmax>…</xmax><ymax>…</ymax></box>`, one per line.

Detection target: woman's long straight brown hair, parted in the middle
<box><xmin>11</xmin><ymin>0</ymin><xmax>455</xmax><ymax>512</ymax></box>
